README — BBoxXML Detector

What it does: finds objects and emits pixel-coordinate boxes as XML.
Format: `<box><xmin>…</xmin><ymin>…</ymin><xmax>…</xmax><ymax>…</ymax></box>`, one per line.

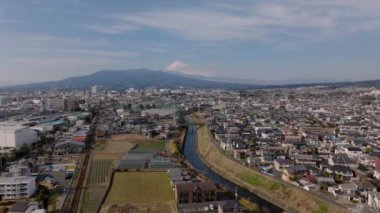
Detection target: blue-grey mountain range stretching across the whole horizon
<box><xmin>1</xmin><ymin>69</ymin><xmax>380</xmax><ymax>89</ymax></box>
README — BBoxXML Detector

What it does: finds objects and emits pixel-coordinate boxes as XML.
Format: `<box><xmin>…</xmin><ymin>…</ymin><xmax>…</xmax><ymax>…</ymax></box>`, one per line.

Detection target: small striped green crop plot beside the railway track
<box><xmin>88</xmin><ymin>160</ymin><xmax>112</xmax><ymax>184</ymax></box>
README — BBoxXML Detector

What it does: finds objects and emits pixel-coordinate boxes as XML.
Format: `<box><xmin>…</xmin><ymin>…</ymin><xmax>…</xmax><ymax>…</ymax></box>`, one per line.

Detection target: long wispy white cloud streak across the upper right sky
<box><xmin>88</xmin><ymin>0</ymin><xmax>380</xmax><ymax>41</ymax></box>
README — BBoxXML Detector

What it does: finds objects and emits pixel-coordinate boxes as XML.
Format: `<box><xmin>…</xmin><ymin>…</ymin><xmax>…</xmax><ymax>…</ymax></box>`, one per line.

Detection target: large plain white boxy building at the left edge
<box><xmin>0</xmin><ymin>124</ymin><xmax>37</xmax><ymax>153</ymax></box>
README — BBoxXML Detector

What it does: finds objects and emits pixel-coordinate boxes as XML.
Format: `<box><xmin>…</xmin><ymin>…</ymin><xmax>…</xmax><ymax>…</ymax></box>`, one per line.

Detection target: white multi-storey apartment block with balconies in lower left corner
<box><xmin>0</xmin><ymin>176</ymin><xmax>36</xmax><ymax>200</ymax></box>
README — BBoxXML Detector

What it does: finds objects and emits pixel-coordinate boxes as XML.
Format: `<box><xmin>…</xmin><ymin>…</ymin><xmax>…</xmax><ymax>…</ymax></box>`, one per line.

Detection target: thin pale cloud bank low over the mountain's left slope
<box><xmin>0</xmin><ymin>35</ymin><xmax>138</xmax><ymax>81</ymax></box>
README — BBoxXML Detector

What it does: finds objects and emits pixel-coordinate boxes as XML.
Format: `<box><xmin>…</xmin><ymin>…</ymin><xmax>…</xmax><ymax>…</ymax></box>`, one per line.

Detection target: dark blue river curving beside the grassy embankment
<box><xmin>184</xmin><ymin>126</ymin><xmax>283</xmax><ymax>213</ymax></box>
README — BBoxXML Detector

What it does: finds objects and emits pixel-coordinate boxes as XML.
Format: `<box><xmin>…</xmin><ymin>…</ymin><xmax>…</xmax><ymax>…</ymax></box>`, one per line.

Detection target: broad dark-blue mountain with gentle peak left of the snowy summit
<box><xmin>4</xmin><ymin>69</ymin><xmax>254</xmax><ymax>89</ymax></box>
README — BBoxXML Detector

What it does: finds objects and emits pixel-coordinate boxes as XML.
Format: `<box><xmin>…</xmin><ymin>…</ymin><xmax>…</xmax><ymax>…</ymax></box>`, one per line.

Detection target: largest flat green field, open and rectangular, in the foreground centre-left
<box><xmin>105</xmin><ymin>172</ymin><xmax>174</xmax><ymax>205</ymax></box>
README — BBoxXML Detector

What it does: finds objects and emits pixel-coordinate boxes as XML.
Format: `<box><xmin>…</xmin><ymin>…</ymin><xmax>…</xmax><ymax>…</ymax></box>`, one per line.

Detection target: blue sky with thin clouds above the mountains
<box><xmin>0</xmin><ymin>0</ymin><xmax>380</xmax><ymax>85</ymax></box>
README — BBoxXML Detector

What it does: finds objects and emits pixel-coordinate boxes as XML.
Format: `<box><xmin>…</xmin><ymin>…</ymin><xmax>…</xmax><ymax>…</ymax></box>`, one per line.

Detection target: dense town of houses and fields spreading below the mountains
<box><xmin>0</xmin><ymin>85</ymin><xmax>380</xmax><ymax>212</ymax></box>
